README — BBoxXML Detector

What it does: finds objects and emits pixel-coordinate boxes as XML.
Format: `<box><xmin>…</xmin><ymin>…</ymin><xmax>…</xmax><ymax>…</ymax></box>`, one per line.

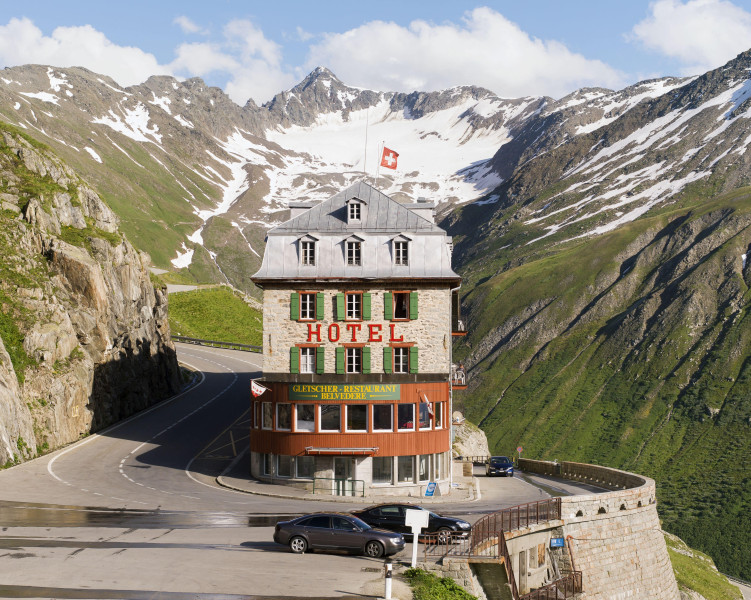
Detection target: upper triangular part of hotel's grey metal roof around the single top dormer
<box><xmin>268</xmin><ymin>181</ymin><xmax>446</xmax><ymax>235</ymax></box>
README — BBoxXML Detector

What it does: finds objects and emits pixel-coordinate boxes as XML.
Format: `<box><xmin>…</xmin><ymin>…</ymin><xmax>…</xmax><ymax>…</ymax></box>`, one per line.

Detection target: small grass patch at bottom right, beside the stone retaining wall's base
<box><xmin>665</xmin><ymin>535</ymin><xmax>742</xmax><ymax>600</ymax></box>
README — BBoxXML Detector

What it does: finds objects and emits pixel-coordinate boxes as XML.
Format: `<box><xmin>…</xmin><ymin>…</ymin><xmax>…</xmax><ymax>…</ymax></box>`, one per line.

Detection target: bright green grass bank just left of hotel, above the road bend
<box><xmin>169</xmin><ymin>287</ymin><xmax>263</xmax><ymax>346</ymax></box>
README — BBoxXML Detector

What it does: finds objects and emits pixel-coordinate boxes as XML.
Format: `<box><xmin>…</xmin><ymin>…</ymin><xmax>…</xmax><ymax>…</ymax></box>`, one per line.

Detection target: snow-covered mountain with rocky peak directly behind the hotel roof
<box><xmin>0</xmin><ymin>65</ymin><xmax>680</xmax><ymax>291</ymax></box>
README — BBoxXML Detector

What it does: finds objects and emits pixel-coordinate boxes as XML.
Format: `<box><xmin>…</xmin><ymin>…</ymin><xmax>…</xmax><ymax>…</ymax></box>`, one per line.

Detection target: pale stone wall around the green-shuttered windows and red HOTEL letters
<box><xmin>263</xmin><ymin>283</ymin><xmax>451</xmax><ymax>374</ymax></box>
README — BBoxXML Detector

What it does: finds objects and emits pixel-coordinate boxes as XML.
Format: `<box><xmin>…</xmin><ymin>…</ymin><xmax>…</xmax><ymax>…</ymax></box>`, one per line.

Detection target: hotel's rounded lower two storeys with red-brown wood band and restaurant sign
<box><xmin>250</xmin><ymin>377</ymin><xmax>451</xmax><ymax>496</ymax></box>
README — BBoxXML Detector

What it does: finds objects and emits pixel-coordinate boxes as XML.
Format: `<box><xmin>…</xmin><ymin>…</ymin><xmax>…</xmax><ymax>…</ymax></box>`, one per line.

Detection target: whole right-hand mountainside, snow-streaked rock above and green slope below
<box><xmin>444</xmin><ymin>53</ymin><xmax>751</xmax><ymax>578</ymax></box>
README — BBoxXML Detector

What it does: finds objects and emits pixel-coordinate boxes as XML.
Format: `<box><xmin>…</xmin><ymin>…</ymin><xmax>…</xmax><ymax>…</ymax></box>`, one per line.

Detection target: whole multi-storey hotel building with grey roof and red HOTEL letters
<box><xmin>250</xmin><ymin>182</ymin><xmax>461</xmax><ymax>496</ymax></box>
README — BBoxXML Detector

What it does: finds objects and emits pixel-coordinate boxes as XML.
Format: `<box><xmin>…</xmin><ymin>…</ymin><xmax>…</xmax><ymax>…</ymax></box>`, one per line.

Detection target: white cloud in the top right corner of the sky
<box><xmin>628</xmin><ymin>0</ymin><xmax>751</xmax><ymax>75</ymax></box>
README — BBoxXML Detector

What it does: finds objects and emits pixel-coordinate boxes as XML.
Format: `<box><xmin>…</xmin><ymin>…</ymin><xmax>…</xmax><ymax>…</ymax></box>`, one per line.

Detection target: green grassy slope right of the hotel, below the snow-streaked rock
<box><xmin>455</xmin><ymin>189</ymin><xmax>751</xmax><ymax>578</ymax></box>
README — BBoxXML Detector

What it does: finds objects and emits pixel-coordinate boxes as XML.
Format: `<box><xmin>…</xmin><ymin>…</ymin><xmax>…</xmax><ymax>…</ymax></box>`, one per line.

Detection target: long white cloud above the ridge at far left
<box><xmin>0</xmin><ymin>18</ymin><xmax>170</xmax><ymax>86</ymax></box>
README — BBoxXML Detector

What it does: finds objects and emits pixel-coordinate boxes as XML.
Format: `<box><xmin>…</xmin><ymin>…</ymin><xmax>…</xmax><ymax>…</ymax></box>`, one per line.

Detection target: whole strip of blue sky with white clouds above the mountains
<box><xmin>0</xmin><ymin>0</ymin><xmax>751</xmax><ymax>104</ymax></box>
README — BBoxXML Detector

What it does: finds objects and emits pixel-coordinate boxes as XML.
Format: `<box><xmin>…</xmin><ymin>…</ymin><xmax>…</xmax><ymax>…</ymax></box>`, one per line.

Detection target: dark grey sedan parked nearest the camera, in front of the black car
<box><xmin>274</xmin><ymin>513</ymin><xmax>404</xmax><ymax>558</ymax></box>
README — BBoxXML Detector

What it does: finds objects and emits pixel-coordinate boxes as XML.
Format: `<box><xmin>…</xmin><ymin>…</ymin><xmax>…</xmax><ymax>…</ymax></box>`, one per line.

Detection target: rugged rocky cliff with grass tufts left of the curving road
<box><xmin>0</xmin><ymin>125</ymin><xmax>179</xmax><ymax>465</ymax></box>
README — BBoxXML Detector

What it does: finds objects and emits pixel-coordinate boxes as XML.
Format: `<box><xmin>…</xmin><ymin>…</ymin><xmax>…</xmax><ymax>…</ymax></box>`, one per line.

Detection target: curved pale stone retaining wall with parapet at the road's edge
<box><xmin>512</xmin><ymin>459</ymin><xmax>680</xmax><ymax>600</ymax></box>
